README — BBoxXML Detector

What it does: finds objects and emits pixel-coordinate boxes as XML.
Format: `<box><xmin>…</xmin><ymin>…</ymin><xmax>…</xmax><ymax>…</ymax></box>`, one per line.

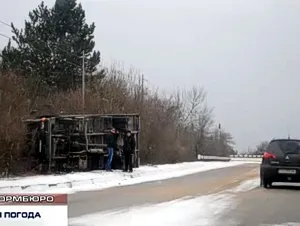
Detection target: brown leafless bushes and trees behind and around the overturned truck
<box><xmin>0</xmin><ymin>64</ymin><xmax>236</xmax><ymax>174</ymax></box>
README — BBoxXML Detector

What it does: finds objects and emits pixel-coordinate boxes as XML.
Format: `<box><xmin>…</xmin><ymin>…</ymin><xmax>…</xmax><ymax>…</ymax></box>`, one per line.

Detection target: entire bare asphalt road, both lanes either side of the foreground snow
<box><xmin>69</xmin><ymin>164</ymin><xmax>300</xmax><ymax>226</ymax></box>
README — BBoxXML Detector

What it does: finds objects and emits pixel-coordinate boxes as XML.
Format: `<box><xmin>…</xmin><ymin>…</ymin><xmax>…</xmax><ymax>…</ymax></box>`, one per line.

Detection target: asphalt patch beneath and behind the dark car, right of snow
<box><xmin>221</xmin><ymin>184</ymin><xmax>300</xmax><ymax>226</ymax></box>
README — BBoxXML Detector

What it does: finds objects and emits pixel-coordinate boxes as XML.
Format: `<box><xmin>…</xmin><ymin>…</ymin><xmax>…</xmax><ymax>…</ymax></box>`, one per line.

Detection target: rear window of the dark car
<box><xmin>268</xmin><ymin>140</ymin><xmax>300</xmax><ymax>154</ymax></box>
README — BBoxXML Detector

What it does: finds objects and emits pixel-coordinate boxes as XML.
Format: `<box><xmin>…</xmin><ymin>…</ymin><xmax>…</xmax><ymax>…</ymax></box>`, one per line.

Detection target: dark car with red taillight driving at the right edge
<box><xmin>260</xmin><ymin>139</ymin><xmax>300</xmax><ymax>188</ymax></box>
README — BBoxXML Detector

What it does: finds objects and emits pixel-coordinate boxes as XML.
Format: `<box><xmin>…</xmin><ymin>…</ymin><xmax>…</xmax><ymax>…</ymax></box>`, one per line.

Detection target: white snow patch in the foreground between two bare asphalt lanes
<box><xmin>69</xmin><ymin>194</ymin><xmax>235</xmax><ymax>226</ymax></box>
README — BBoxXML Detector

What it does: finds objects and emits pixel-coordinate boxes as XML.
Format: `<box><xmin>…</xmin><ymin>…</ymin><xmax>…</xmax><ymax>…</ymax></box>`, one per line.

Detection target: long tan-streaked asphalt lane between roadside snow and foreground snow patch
<box><xmin>69</xmin><ymin>164</ymin><xmax>258</xmax><ymax>218</ymax></box>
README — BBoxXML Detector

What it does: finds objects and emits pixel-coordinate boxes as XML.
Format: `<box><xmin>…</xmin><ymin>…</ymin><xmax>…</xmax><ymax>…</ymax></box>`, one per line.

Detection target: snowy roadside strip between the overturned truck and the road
<box><xmin>0</xmin><ymin>161</ymin><xmax>255</xmax><ymax>193</ymax></box>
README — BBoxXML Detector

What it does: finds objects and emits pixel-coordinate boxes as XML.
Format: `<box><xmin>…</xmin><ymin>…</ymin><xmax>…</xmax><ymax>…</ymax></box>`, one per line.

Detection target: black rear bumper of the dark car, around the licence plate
<box><xmin>261</xmin><ymin>165</ymin><xmax>300</xmax><ymax>182</ymax></box>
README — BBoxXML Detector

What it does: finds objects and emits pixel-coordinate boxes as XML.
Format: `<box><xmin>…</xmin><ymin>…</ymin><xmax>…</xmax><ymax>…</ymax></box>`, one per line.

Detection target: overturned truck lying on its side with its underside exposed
<box><xmin>24</xmin><ymin>114</ymin><xmax>140</xmax><ymax>173</ymax></box>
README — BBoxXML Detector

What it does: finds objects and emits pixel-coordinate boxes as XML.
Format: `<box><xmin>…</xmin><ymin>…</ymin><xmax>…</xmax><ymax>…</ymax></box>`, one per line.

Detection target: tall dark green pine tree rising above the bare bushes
<box><xmin>2</xmin><ymin>0</ymin><xmax>100</xmax><ymax>89</ymax></box>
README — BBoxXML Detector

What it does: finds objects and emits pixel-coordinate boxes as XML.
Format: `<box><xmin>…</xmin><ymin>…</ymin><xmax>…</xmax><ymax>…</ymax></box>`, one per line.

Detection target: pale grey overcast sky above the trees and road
<box><xmin>0</xmin><ymin>0</ymin><xmax>300</xmax><ymax>151</ymax></box>
